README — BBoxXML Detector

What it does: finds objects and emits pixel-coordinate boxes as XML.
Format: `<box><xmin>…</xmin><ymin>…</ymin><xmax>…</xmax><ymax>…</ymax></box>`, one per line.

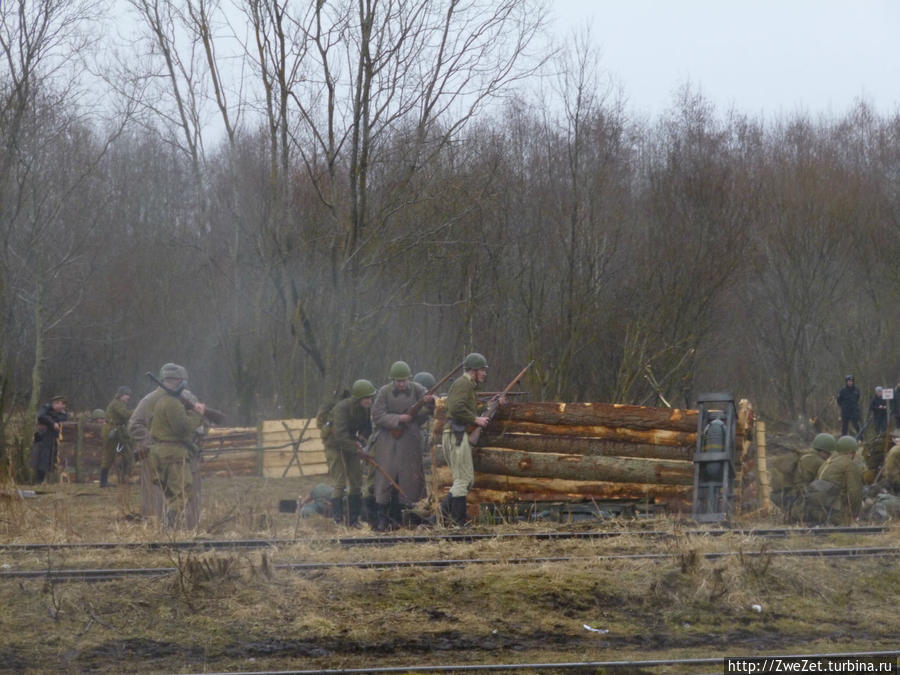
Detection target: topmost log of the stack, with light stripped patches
<box><xmin>495</xmin><ymin>402</ymin><xmax>697</xmax><ymax>432</ymax></box>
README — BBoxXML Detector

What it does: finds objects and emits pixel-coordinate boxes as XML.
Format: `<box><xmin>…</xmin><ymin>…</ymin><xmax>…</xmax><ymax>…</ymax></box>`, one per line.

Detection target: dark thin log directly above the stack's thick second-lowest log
<box><xmin>482</xmin><ymin>433</ymin><xmax>695</xmax><ymax>462</ymax></box>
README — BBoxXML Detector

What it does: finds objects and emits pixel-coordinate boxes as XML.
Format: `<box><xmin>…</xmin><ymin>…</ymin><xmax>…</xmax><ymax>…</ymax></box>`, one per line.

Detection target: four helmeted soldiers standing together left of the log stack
<box><xmin>319</xmin><ymin>352</ymin><xmax>489</xmax><ymax>531</ymax></box>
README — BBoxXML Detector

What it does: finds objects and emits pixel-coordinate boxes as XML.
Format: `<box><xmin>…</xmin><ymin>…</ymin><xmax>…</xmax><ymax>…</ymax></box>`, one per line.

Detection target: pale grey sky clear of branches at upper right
<box><xmin>551</xmin><ymin>0</ymin><xmax>900</xmax><ymax>116</ymax></box>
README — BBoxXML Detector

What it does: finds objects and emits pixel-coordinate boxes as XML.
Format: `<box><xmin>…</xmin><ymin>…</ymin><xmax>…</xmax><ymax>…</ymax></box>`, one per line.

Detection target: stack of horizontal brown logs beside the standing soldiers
<box><xmin>433</xmin><ymin>401</ymin><xmax>742</xmax><ymax>507</ymax></box>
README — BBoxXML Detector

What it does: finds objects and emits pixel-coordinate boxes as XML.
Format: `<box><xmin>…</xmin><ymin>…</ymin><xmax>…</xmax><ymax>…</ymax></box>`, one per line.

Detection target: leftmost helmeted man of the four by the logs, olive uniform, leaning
<box><xmin>323</xmin><ymin>380</ymin><xmax>376</xmax><ymax>527</ymax></box>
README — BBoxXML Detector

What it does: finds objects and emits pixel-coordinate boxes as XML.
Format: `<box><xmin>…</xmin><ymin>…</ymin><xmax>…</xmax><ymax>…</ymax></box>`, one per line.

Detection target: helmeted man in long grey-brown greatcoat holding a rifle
<box><xmin>372</xmin><ymin>361</ymin><xmax>434</xmax><ymax>532</ymax></box>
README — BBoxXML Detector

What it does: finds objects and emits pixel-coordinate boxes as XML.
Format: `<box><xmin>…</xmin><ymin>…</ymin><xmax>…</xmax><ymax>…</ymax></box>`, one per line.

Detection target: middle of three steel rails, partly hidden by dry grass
<box><xmin>0</xmin><ymin>546</ymin><xmax>900</xmax><ymax>581</ymax></box>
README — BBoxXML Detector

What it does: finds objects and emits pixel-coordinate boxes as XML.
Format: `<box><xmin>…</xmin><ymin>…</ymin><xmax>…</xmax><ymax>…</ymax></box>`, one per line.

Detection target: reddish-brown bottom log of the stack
<box><xmin>434</xmin><ymin>467</ymin><xmax>693</xmax><ymax>502</ymax></box>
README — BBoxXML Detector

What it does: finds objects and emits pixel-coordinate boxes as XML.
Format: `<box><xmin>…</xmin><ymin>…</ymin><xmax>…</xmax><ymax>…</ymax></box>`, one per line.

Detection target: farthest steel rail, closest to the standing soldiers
<box><xmin>0</xmin><ymin>525</ymin><xmax>891</xmax><ymax>552</ymax></box>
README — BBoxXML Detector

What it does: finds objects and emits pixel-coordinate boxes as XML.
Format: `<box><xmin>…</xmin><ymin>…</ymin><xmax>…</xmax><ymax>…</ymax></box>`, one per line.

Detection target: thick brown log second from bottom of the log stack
<box><xmin>472</xmin><ymin>448</ymin><xmax>694</xmax><ymax>485</ymax></box>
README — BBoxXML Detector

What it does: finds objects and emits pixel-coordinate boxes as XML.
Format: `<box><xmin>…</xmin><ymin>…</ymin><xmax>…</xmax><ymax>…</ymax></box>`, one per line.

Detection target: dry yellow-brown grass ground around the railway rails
<box><xmin>0</xmin><ymin>478</ymin><xmax>900</xmax><ymax>673</ymax></box>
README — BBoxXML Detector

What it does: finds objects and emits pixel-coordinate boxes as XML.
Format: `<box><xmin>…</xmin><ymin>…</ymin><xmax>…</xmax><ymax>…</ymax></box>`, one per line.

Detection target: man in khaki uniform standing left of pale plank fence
<box><xmin>149</xmin><ymin>364</ymin><xmax>206</xmax><ymax>528</ymax></box>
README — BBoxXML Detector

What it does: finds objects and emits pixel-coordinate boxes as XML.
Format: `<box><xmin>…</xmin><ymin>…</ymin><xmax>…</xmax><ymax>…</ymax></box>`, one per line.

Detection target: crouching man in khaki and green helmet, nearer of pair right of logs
<box><xmin>791</xmin><ymin>436</ymin><xmax>863</xmax><ymax>525</ymax></box>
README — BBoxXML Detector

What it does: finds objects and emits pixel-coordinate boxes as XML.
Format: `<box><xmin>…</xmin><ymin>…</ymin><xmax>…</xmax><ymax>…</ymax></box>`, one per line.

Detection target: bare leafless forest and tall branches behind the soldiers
<box><xmin>0</xmin><ymin>0</ymin><xmax>900</xmax><ymax>480</ymax></box>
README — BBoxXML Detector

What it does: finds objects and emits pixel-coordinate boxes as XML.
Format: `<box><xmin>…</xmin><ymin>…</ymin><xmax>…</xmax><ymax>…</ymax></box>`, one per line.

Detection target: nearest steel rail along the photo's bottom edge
<box><xmin>185</xmin><ymin>651</ymin><xmax>900</xmax><ymax>675</ymax></box>
